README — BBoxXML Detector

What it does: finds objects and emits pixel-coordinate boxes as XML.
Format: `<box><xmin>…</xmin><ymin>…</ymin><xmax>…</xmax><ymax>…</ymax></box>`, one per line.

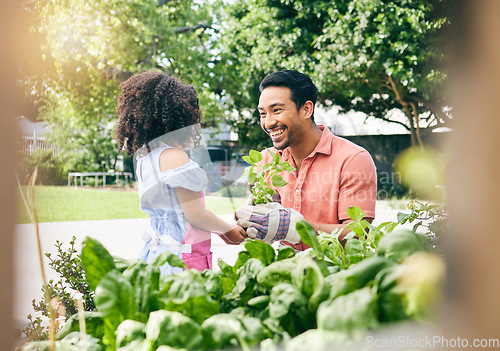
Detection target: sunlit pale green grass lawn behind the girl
<box><xmin>17</xmin><ymin>186</ymin><xmax>245</xmax><ymax>224</ymax></box>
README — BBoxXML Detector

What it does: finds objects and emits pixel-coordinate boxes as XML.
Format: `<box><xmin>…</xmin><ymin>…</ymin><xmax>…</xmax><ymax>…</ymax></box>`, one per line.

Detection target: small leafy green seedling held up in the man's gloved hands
<box><xmin>243</xmin><ymin>149</ymin><xmax>295</xmax><ymax>205</ymax></box>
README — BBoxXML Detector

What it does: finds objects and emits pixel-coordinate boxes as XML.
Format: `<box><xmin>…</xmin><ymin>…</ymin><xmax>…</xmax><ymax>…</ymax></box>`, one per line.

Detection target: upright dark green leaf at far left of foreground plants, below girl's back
<box><xmin>81</xmin><ymin>237</ymin><xmax>115</xmax><ymax>291</ymax></box>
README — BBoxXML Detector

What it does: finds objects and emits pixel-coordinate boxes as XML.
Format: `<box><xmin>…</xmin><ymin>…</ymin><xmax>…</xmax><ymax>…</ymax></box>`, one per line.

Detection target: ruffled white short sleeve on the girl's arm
<box><xmin>160</xmin><ymin>160</ymin><xmax>208</xmax><ymax>191</ymax></box>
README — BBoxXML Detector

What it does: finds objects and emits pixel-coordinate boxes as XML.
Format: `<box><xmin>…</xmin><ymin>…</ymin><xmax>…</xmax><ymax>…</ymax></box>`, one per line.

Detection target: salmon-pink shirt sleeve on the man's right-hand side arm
<box><xmin>338</xmin><ymin>151</ymin><xmax>377</xmax><ymax>221</ymax></box>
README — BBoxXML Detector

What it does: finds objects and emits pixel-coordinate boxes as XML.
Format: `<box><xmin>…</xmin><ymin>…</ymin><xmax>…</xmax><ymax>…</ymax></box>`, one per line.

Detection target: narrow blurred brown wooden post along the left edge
<box><xmin>0</xmin><ymin>0</ymin><xmax>27</xmax><ymax>350</ymax></box>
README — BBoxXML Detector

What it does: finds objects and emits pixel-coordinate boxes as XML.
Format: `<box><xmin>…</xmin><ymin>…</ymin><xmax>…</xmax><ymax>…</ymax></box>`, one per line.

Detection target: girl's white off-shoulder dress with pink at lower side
<box><xmin>136</xmin><ymin>146</ymin><xmax>212</xmax><ymax>274</ymax></box>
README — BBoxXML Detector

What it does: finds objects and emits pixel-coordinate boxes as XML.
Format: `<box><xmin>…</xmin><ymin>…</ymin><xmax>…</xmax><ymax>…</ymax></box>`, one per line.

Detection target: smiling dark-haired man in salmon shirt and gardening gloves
<box><xmin>236</xmin><ymin>70</ymin><xmax>377</xmax><ymax>250</ymax></box>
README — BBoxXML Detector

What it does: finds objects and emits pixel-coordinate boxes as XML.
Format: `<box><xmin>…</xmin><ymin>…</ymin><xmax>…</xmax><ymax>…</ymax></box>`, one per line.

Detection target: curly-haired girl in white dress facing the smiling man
<box><xmin>116</xmin><ymin>72</ymin><xmax>246</xmax><ymax>274</ymax></box>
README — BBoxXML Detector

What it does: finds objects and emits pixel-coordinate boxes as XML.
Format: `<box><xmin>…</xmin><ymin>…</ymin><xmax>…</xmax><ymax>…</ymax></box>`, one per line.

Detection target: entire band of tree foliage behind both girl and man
<box><xmin>22</xmin><ymin>0</ymin><xmax>451</xmax><ymax>170</ymax></box>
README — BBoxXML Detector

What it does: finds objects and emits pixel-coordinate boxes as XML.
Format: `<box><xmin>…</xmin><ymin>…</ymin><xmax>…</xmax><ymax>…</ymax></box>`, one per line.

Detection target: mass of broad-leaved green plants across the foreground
<box><xmin>22</xmin><ymin>208</ymin><xmax>444</xmax><ymax>350</ymax></box>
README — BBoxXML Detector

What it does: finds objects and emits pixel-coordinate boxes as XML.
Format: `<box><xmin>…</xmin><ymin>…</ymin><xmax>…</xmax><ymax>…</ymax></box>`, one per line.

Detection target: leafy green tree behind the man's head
<box><xmin>218</xmin><ymin>0</ymin><xmax>451</xmax><ymax>145</ymax></box>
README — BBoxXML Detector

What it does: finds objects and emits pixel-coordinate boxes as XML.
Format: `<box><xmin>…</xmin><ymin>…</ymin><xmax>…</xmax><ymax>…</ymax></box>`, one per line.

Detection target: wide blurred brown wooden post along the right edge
<box><xmin>443</xmin><ymin>0</ymin><xmax>500</xmax><ymax>342</ymax></box>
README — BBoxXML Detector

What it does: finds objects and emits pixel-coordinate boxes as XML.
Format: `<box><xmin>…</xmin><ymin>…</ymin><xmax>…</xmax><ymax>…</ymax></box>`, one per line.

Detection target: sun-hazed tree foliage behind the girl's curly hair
<box><xmin>22</xmin><ymin>0</ymin><xmax>222</xmax><ymax>170</ymax></box>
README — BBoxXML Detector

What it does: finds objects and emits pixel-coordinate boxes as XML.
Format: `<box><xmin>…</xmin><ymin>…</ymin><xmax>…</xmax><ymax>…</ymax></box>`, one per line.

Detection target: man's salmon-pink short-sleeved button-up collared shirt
<box><xmin>262</xmin><ymin>125</ymin><xmax>377</xmax><ymax>250</ymax></box>
